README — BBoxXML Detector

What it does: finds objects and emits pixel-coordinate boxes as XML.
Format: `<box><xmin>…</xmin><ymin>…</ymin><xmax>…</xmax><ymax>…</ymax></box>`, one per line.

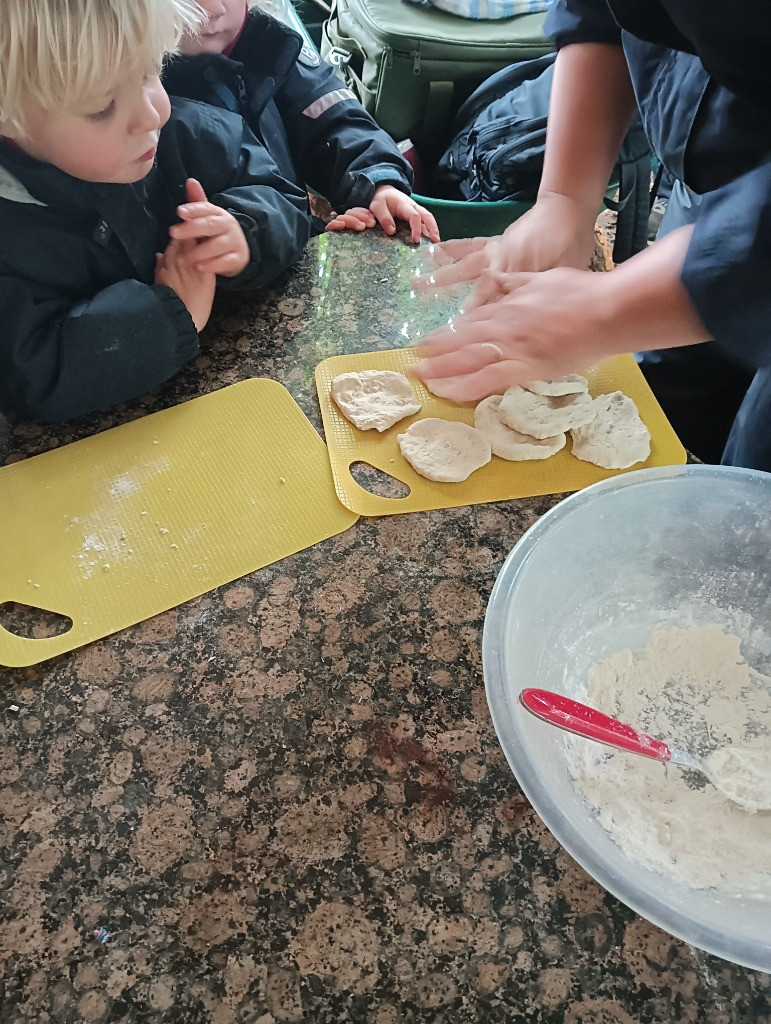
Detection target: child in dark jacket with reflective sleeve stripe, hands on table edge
<box><xmin>164</xmin><ymin>0</ymin><xmax>439</xmax><ymax>242</ymax></box>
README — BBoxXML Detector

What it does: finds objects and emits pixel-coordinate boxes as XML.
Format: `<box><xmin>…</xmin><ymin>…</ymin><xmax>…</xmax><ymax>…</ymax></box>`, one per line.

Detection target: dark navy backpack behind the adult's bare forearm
<box><xmin>435</xmin><ymin>53</ymin><xmax>651</xmax><ymax>263</ymax></box>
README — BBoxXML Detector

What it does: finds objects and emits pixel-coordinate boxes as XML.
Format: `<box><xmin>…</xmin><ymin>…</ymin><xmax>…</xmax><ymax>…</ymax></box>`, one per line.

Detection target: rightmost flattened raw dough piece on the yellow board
<box><xmin>570</xmin><ymin>391</ymin><xmax>650</xmax><ymax>469</ymax></box>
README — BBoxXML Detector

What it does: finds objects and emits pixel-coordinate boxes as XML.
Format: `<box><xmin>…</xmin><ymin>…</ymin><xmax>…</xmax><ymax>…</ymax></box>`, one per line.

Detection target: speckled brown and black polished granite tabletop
<box><xmin>0</xmin><ymin>234</ymin><xmax>771</xmax><ymax>1024</ymax></box>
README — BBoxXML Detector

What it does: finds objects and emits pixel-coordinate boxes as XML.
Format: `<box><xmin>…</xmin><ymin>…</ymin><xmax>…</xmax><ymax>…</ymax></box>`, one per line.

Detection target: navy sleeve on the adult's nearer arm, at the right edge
<box><xmin>682</xmin><ymin>161</ymin><xmax>771</xmax><ymax>369</ymax></box>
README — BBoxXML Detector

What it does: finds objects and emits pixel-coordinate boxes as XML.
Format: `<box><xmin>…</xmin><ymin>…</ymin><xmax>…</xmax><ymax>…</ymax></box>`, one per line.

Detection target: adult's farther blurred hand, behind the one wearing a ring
<box><xmin>415</xmin><ymin>194</ymin><xmax>596</xmax><ymax>309</ymax></box>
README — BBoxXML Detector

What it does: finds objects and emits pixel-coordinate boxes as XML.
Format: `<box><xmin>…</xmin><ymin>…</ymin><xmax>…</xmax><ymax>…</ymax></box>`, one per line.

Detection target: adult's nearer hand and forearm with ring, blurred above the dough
<box><xmin>417</xmin><ymin>226</ymin><xmax>711</xmax><ymax>401</ymax></box>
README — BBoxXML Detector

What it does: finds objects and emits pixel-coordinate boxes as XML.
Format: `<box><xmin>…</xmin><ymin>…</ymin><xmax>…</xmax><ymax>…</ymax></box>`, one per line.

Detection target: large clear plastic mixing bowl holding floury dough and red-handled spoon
<box><xmin>483</xmin><ymin>466</ymin><xmax>771</xmax><ymax>972</ymax></box>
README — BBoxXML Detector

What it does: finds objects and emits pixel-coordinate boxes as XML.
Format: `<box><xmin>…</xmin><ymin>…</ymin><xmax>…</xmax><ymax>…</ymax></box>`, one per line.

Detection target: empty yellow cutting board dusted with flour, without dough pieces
<box><xmin>0</xmin><ymin>380</ymin><xmax>357</xmax><ymax>667</ymax></box>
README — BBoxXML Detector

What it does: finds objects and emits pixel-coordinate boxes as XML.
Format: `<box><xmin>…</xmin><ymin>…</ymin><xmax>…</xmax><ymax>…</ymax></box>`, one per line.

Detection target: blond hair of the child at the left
<box><xmin>0</xmin><ymin>0</ymin><xmax>204</xmax><ymax>129</ymax></box>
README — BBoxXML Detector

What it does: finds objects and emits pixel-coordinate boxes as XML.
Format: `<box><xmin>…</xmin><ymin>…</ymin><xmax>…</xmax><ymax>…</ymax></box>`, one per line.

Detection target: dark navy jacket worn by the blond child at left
<box><xmin>0</xmin><ymin>93</ymin><xmax>311</xmax><ymax>421</ymax></box>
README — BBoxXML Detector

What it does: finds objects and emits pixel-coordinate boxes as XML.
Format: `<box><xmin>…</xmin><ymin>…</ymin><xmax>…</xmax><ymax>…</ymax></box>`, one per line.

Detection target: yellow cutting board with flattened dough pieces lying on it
<box><xmin>315</xmin><ymin>348</ymin><xmax>686</xmax><ymax>516</ymax></box>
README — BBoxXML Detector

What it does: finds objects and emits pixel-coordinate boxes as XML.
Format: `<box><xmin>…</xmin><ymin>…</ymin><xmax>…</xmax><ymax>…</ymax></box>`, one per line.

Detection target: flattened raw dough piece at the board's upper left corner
<box><xmin>332</xmin><ymin>370</ymin><xmax>422</xmax><ymax>431</ymax></box>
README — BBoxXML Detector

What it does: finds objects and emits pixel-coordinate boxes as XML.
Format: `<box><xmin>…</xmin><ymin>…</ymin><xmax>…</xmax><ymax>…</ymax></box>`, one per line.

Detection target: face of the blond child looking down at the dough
<box><xmin>8</xmin><ymin>73</ymin><xmax>171</xmax><ymax>184</ymax></box>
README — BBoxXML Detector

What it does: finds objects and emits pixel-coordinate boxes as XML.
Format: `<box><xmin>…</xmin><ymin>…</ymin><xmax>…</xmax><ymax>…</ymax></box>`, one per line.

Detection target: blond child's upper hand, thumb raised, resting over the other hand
<box><xmin>169</xmin><ymin>178</ymin><xmax>251</xmax><ymax>278</ymax></box>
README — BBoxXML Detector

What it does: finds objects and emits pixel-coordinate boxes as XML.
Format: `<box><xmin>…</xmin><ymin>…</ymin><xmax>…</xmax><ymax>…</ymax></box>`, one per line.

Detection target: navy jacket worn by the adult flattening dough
<box><xmin>546</xmin><ymin>0</ymin><xmax>771</xmax><ymax>367</ymax></box>
